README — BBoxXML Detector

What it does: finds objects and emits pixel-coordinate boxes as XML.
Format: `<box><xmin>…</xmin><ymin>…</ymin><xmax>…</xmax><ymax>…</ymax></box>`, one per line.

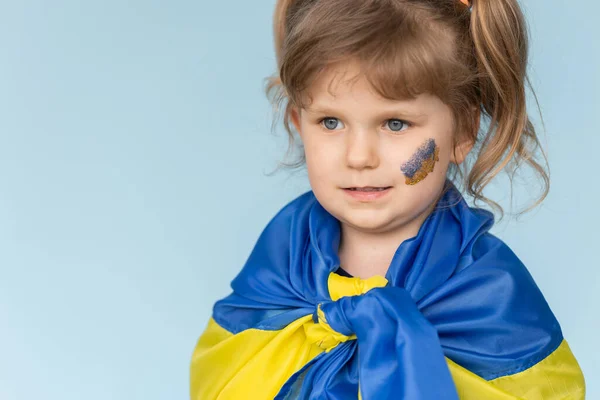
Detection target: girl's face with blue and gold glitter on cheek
<box><xmin>291</xmin><ymin>60</ymin><xmax>470</xmax><ymax>232</ymax></box>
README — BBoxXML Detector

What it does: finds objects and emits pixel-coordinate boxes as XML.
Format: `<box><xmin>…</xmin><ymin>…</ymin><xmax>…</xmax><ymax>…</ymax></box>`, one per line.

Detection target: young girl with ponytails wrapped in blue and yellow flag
<box><xmin>190</xmin><ymin>0</ymin><xmax>585</xmax><ymax>400</ymax></box>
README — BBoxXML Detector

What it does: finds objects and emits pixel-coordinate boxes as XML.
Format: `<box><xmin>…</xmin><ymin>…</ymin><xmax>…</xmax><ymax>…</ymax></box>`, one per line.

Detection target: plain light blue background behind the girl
<box><xmin>0</xmin><ymin>0</ymin><xmax>600</xmax><ymax>400</ymax></box>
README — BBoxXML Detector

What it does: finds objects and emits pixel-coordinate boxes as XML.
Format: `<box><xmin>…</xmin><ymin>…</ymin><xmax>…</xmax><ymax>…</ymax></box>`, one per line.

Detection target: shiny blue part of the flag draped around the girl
<box><xmin>213</xmin><ymin>181</ymin><xmax>563</xmax><ymax>400</ymax></box>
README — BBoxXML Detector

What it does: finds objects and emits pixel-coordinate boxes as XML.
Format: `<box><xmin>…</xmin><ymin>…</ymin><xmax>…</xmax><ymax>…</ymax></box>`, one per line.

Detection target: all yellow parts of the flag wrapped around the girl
<box><xmin>190</xmin><ymin>273</ymin><xmax>585</xmax><ymax>400</ymax></box>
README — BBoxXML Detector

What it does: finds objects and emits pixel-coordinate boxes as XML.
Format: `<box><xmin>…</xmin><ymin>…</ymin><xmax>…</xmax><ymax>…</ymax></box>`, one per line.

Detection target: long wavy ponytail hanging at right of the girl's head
<box><xmin>467</xmin><ymin>0</ymin><xmax>549</xmax><ymax>214</ymax></box>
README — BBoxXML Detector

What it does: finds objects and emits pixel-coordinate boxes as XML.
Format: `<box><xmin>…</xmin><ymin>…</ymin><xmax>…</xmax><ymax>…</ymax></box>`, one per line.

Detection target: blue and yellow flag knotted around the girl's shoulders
<box><xmin>190</xmin><ymin>185</ymin><xmax>585</xmax><ymax>400</ymax></box>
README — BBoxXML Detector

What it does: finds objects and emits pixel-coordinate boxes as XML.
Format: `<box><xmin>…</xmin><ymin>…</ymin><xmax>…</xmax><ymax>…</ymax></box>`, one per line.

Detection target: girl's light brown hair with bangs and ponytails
<box><xmin>266</xmin><ymin>0</ymin><xmax>549</xmax><ymax>219</ymax></box>
